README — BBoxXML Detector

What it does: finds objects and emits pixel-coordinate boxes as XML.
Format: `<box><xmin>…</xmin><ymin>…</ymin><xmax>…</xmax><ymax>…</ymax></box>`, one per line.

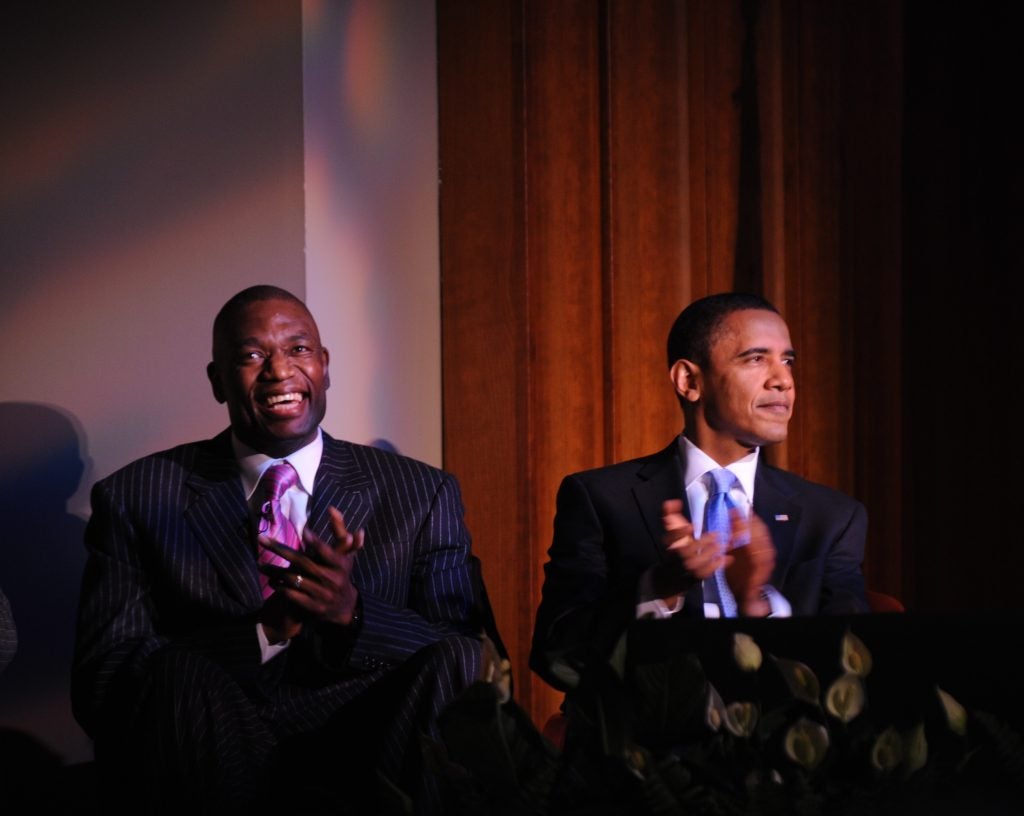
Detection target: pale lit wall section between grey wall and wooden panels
<box><xmin>302</xmin><ymin>0</ymin><xmax>441</xmax><ymax>466</ymax></box>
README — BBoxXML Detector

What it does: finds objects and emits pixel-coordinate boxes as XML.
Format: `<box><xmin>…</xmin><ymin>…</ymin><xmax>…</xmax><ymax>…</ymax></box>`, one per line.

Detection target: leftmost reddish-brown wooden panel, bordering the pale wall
<box><xmin>437</xmin><ymin>2</ymin><xmax>537</xmax><ymax>695</ymax></box>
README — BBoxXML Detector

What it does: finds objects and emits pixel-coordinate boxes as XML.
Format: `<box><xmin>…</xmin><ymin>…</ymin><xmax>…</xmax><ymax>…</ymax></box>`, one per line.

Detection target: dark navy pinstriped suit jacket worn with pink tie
<box><xmin>72</xmin><ymin>430</ymin><xmax>478</xmax><ymax>737</ymax></box>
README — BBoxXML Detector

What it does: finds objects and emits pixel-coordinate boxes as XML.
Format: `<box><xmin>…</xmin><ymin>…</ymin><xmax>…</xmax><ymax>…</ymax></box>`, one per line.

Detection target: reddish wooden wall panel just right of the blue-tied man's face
<box><xmin>769</xmin><ymin>3</ymin><xmax>852</xmax><ymax>490</ymax></box>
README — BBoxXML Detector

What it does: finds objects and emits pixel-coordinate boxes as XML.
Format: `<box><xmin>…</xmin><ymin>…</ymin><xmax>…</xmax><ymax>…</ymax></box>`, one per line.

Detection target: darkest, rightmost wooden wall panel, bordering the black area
<box><xmin>840</xmin><ymin>0</ymin><xmax>916</xmax><ymax>597</ymax></box>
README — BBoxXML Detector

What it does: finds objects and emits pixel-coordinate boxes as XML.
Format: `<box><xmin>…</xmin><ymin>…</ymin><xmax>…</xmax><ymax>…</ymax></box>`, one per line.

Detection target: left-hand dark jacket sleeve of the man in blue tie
<box><xmin>529</xmin><ymin>475</ymin><xmax>638</xmax><ymax>691</ymax></box>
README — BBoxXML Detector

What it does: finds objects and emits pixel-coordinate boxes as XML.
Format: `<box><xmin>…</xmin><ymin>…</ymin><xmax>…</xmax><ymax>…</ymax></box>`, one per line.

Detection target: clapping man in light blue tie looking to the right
<box><xmin>530</xmin><ymin>293</ymin><xmax>868</xmax><ymax>691</ymax></box>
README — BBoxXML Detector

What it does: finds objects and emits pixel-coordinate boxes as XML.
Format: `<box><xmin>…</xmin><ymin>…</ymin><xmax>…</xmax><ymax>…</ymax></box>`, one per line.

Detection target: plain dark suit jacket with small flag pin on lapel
<box><xmin>530</xmin><ymin>440</ymin><xmax>868</xmax><ymax>690</ymax></box>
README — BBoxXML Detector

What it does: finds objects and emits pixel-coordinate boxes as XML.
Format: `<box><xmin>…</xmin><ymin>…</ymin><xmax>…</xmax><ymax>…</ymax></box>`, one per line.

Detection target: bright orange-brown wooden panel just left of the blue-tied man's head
<box><xmin>605</xmin><ymin>0</ymin><xmax>692</xmax><ymax>461</ymax></box>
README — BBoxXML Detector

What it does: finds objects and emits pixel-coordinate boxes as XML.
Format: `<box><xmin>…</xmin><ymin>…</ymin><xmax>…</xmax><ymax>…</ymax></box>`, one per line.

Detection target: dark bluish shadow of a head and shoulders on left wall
<box><xmin>0</xmin><ymin>402</ymin><xmax>92</xmax><ymax>775</ymax></box>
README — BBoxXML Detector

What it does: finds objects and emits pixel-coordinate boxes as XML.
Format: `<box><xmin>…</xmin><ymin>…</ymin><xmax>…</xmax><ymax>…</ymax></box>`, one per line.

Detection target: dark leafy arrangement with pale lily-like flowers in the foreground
<box><xmin>434</xmin><ymin>629</ymin><xmax>1024</xmax><ymax>816</ymax></box>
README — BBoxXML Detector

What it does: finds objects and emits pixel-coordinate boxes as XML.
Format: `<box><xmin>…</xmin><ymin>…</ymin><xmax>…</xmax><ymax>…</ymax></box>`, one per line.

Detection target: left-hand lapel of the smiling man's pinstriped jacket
<box><xmin>184</xmin><ymin>431</ymin><xmax>262</xmax><ymax>607</ymax></box>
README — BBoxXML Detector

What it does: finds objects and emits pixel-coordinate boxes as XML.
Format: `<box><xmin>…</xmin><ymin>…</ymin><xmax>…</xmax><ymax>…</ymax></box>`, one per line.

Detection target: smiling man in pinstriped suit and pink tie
<box><xmin>72</xmin><ymin>286</ymin><xmax>488</xmax><ymax>813</ymax></box>
